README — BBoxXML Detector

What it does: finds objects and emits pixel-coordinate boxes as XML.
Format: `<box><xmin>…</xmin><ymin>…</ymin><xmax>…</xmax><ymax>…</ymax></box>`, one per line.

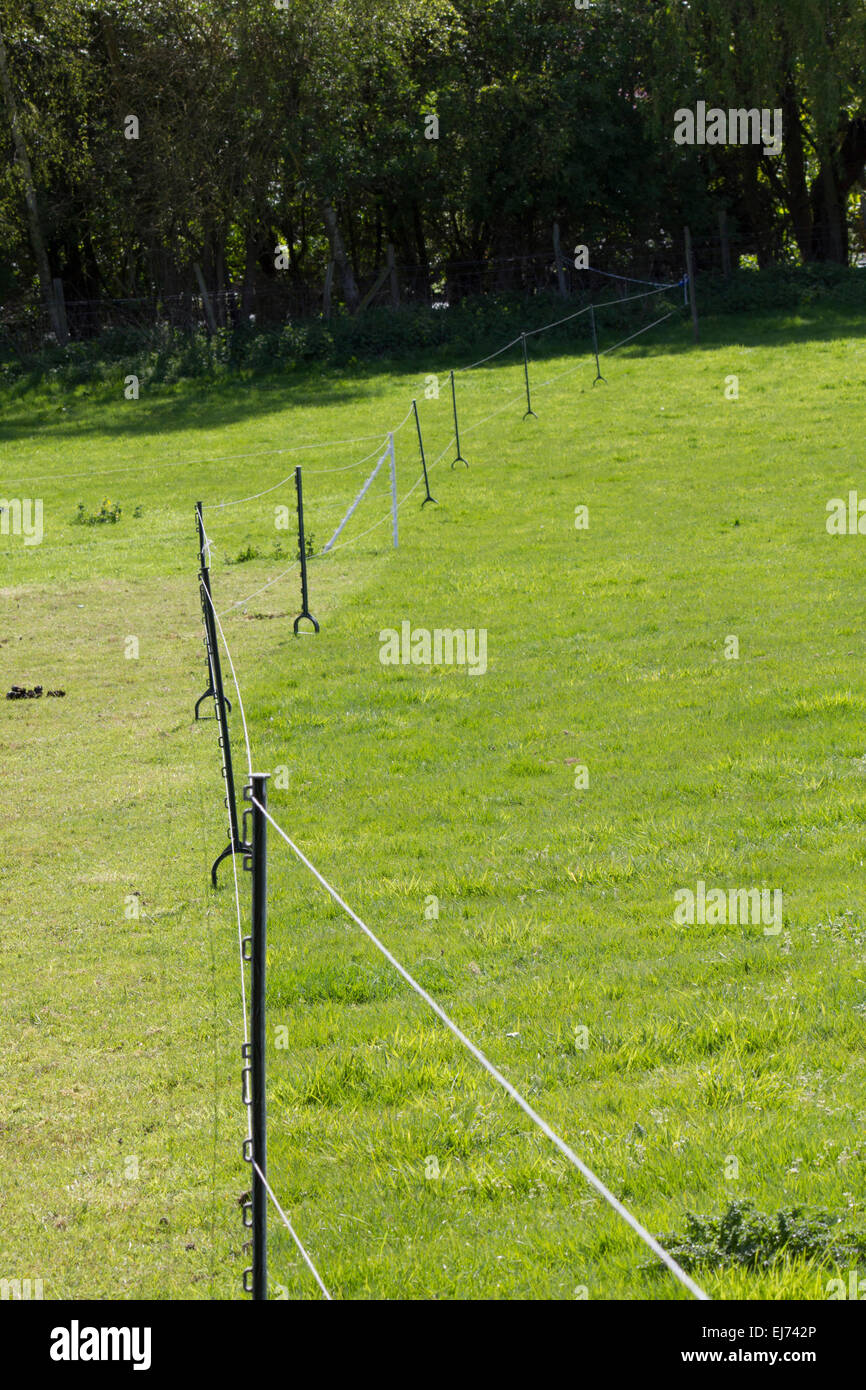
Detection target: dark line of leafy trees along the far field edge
<box><xmin>0</xmin><ymin>0</ymin><xmax>866</xmax><ymax>330</ymax></box>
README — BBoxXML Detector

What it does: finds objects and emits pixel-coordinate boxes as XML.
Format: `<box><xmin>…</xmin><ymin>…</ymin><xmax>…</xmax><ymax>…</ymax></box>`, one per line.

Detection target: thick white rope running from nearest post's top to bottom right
<box><xmin>252</xmin><ymin>796</ymin><xmax>710</xmax><ymax>1302</ymax></box>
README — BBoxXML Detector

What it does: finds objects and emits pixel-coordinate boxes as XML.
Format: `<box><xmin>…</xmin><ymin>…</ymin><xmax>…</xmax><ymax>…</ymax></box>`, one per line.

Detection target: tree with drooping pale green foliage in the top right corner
<box><xmin>646</xmin><ymin>0</ymin><xmax>866</xmax><ymax>264</ymax></box>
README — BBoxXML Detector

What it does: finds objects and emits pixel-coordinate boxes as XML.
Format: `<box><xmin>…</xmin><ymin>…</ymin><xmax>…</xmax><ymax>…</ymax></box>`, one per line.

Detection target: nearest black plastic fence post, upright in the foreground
<box><xmin>243</xmin><ymin>773</ymin><xmax>268</xmax><ymax>1300</ymax></box>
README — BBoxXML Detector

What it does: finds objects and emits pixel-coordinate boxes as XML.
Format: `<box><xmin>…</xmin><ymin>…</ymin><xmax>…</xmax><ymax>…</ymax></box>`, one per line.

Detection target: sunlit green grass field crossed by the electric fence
<box><xmin>0</xmin><ymin>310</ymin><xmax>866</xmax><ymax>1300</ymax></box>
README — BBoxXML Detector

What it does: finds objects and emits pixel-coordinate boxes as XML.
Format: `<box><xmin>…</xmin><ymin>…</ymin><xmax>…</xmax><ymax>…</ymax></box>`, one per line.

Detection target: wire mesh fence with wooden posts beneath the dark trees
<box><xmin>0</xmin><ymin>217</ymin><xmax>866</xmax><ymax>356</ymax></box>
